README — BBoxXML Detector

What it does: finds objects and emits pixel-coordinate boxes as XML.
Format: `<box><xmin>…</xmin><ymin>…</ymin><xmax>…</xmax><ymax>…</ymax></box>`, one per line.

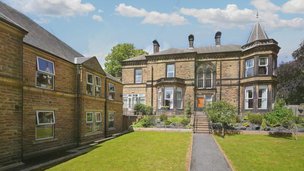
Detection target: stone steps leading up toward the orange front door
<box><xmin>193</xmin><ymin>112</ymin><xmax>210</xmax><ymax>134</ymax></box>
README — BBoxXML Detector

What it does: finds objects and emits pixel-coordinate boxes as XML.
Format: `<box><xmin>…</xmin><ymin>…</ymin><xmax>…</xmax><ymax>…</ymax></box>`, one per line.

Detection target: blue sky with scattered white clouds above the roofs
<box><xmin>0</xmin><ymin>0</ymin><xmax>304</xmax><ymax>64</ymax></box>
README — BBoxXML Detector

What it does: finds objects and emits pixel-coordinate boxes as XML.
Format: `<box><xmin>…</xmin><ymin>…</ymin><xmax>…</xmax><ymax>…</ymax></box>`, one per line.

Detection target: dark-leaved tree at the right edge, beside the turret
<box><xmin>277</xmin><ymin>43</ymin><xmax>304</xmax><ymax>104</ymax></box>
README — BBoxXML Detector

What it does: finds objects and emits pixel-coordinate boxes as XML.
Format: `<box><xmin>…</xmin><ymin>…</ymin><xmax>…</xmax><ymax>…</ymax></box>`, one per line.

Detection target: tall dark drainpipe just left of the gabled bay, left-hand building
<box><xmin>76</xmin><ymin>65</ymin><xmax>82</xmax><ymax>146</ymax></box>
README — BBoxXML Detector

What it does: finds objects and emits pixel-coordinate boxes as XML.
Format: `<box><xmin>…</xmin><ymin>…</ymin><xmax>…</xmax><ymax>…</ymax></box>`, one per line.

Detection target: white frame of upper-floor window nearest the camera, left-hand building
<box><xmin>35</xmin><ymin>56</ymin><xmax>55</xmax><ymax>90</ymax></box>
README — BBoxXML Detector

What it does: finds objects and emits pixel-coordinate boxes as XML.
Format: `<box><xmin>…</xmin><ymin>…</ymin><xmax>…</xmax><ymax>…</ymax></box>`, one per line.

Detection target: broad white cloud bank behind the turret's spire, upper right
<box><xmin>180</xmin><ymin>3</ymin><xmax>304</xmax><ymax>28</ymax></box>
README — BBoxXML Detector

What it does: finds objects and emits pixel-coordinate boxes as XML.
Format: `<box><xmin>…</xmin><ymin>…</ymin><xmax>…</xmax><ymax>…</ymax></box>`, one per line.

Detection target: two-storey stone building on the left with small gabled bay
<box><xmin>0</xmin><ymin>2</ymin><xmax>123</xmax><ymax>170</ymax></box>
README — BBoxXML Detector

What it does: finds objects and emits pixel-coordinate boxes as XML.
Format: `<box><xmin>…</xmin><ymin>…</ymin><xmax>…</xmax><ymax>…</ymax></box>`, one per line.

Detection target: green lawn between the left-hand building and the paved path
<box><xmin>50</xmin><ymin>132</ymin><xmax>191</xmax><ymax>171</ymax></box>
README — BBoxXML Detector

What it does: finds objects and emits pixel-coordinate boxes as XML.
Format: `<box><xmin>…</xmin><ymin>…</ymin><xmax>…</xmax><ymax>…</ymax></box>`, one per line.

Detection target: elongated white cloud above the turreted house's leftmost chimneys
<box><xmin>115</xmin><ymin>3</ymin><xmax>187</xmax><ymax>25</ymax></box>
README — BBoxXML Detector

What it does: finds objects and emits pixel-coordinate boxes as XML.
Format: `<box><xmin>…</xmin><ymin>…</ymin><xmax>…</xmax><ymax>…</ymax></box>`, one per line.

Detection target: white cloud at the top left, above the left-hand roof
<box><xmin>4</xmin><ymin>0</ymin><xmax>95</xmax><ymax>17</ymax></box>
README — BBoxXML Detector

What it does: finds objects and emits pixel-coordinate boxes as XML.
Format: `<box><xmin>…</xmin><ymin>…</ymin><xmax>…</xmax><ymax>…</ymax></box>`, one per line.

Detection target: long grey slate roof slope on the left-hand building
<box><xmin>0</xmin><ymin>1</ymin><xmax>83</xmax><ymax>63</ymax></box>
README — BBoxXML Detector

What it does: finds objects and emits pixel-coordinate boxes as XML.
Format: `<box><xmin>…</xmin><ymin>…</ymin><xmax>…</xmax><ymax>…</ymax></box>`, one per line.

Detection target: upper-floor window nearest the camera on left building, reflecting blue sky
<box><xmin>36</xmin><ymin>57</ymin><xmax>55</xmax><ymax>89</ymax></box>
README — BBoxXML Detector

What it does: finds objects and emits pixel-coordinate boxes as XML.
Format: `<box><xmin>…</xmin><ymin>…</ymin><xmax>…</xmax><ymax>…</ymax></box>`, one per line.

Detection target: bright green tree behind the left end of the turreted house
<box><xmin>105</xmin><ymin>43</ymin><xmax>148</xmax><ymax>77</ymax></box>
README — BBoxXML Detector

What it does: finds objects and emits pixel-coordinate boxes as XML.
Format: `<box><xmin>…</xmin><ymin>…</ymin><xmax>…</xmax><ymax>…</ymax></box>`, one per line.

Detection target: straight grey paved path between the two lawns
<box><xmin>190</xmin><ymin>134</ymin><xmax>231</xmax><ymax>171</ymax></box>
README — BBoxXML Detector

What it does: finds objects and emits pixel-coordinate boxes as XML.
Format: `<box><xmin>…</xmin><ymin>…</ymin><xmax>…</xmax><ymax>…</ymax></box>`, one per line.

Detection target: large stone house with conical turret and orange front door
<box><xmin>122</xmin><ymin>22</ymin><xmax>280</xmax><ymax>114</ymax></box>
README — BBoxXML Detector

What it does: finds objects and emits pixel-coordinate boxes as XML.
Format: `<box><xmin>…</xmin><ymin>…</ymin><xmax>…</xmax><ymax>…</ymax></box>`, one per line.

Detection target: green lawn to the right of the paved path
<box><xmin>215</xmin><ymin>135</ymin><xmax>304</xmax><ymax>171</ymax></box>
